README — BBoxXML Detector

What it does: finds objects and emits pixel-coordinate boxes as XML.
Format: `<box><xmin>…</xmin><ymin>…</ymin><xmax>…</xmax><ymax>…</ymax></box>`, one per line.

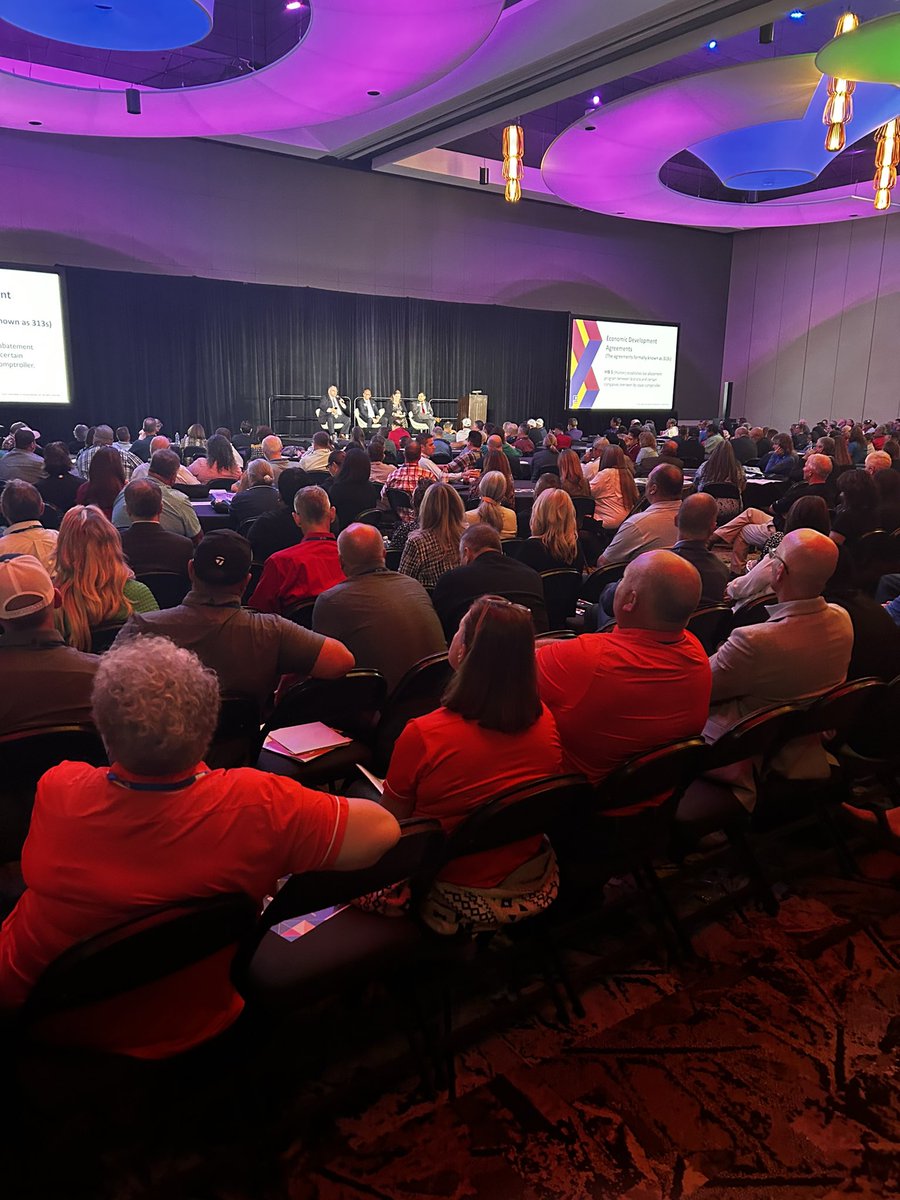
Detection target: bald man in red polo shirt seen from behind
<box><xmin>538</xmin><ymin>550</ymin><xmax>712</xmax><ymax>784</ymax></box>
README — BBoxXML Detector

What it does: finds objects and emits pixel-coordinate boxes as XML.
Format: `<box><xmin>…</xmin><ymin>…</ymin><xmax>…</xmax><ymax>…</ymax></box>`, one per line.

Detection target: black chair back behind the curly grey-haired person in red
<box><xmin>22</xmin><ymin>894</ymin><xmax>258</xmax><ymax>1024</ymax></box>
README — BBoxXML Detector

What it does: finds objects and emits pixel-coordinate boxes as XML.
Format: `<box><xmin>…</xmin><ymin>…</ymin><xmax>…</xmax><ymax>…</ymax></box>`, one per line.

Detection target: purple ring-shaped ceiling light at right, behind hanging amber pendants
<box><xmin>541</xmin><ymin>54</ymin><xmax>900</xmax><ymax>229</ymax></box>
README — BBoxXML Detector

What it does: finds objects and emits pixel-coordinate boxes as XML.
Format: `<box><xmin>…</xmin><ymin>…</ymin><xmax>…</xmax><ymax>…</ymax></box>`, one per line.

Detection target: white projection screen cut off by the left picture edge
<box><xmin>0</xmin><ymin>266</ymin><xmax>72</xmax><ymax>408</ymax></box>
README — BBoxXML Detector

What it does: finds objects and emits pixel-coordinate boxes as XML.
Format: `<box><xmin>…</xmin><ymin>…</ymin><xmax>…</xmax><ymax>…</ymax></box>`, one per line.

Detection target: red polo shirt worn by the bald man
<box><xmin>538</xmin><ymin>629</ymin><xmax>713</xmax><ymax>784</ymax></box>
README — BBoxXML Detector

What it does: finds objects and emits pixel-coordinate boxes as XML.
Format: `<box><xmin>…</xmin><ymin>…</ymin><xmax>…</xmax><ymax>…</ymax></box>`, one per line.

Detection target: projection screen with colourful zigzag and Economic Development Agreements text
<box><xmin>568</xmin><ymin>317</ymin><xmax>678</xmax><ymax>413</ymax></box>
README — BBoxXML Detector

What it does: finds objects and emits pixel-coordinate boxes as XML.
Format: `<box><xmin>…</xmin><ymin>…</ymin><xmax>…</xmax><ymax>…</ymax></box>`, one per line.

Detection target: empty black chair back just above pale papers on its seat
<box><xmin>265</xmin><ymin>668</ymin><xmax>388</xmax><ymax>737</ymax></box>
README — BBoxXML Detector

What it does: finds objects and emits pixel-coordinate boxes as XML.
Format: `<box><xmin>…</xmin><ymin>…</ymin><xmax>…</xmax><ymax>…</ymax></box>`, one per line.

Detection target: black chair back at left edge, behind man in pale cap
<box><xmin>0</xmin><ymin>724</ymin><xmax>107</xmax><ymax>863</ymax></box>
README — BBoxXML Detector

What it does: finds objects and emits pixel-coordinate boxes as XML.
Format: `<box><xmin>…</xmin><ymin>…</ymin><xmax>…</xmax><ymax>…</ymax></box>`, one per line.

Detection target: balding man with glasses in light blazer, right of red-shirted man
<box><xmin>705</xmin><ymin>530</ymin><xmax>862</xmax><ymax>818</ymax></box>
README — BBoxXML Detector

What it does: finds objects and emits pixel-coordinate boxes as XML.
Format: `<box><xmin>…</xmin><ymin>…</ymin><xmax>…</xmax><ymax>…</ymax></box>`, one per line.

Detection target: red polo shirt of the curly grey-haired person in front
<box><xmin>0</xmin><ymin>762</ymin><xmax>347</xmax><ymax>1058</ymax></box>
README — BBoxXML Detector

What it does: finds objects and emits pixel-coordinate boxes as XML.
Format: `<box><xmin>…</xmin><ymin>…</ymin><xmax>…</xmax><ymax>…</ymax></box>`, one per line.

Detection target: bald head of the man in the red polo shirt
<box><xmin>613</xmin><ymin>550</ymin><xmax>702</xmax><ymax>632</ymax></box>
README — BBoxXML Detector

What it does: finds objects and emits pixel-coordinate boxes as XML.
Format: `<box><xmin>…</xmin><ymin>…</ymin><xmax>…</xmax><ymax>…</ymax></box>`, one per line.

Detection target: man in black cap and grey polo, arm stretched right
<box><xmin>116</xmin><ymin>529</ymin><xmax>353</xmax><ymax>707</ymax></box>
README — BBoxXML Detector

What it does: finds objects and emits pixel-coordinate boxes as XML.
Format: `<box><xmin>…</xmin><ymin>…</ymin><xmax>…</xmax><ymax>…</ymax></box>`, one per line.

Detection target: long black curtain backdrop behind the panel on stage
<box><xmin>12</xmin><ymin>268</ymin><xmax>568</xmax><ymax>442</ymax></box>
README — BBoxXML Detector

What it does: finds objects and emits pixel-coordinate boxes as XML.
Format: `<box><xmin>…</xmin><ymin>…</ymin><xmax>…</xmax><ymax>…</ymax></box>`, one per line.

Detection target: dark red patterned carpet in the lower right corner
<box><xmin>289</xmin><ymin>859</ymin><xmax>900</xmax><ymax>1200</ymax></box>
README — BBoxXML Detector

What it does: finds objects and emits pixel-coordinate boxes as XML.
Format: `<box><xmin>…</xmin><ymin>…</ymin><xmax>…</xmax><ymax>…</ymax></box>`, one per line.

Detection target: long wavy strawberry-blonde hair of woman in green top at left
<box><xmin>55</xmin><ymin>504</ymin><xmax>132</xmax><ymax>650</ymax></box>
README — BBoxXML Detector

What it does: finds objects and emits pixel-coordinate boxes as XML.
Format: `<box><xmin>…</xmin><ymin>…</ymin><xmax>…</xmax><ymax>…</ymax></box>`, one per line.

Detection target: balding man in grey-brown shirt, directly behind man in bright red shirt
<box><xmin>312</xmin><ymin>525</ymin><xmax>446</xmax><ymax>691</ymax></box>
